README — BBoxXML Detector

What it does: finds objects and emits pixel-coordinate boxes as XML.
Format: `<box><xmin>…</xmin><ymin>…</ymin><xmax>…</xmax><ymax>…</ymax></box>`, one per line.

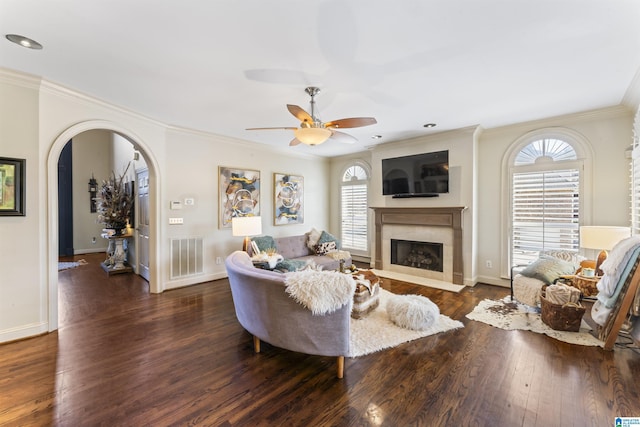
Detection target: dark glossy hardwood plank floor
<box><xmin>0</xmin><ymin>254</ymin><xmax>640</xmax><ymax>426</ymax></box>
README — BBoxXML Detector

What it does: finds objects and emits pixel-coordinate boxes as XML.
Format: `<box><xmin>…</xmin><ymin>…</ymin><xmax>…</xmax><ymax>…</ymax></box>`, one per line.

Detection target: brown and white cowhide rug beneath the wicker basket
<box><xmin>467</xmin><ymin>296</ymin><xmax>604</xmax><ymax>347</ymax></box>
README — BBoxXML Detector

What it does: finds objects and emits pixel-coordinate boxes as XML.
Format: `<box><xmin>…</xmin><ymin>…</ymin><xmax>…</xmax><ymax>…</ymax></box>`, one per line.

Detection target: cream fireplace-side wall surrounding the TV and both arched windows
<box><xmin>331</xmin><ymin>106</ymin><xmax>633</xmax><ymax>286</ymax></box>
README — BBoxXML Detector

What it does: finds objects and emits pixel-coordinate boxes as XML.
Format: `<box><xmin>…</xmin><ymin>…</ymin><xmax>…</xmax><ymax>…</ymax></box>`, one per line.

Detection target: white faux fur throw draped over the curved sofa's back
<box><xmin>284</xmin><ymin>270</ymin><xmax>356</xmax><ymax>315</ymax></box>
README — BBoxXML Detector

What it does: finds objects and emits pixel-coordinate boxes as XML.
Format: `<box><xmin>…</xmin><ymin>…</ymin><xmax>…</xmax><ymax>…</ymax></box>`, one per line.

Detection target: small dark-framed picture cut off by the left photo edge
<box><xmin>0</xmin><ymin>157</ymin><xmax>25</xmax><ymax>216</ymax></box>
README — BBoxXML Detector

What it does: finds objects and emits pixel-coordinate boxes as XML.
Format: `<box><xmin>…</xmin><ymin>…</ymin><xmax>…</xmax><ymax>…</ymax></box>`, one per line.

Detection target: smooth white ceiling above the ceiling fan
<box><xmin>0</xmin><ymin>0</ymin><xmax>640</xmax><ymax>156</ymax></box>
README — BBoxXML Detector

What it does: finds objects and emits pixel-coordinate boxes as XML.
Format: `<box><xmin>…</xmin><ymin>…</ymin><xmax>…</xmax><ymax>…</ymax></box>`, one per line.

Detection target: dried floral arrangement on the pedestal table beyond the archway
<box><xmin>95</xmin><ymin>166</ymin><xmax>133</xmax><ymax>235</ymax></box>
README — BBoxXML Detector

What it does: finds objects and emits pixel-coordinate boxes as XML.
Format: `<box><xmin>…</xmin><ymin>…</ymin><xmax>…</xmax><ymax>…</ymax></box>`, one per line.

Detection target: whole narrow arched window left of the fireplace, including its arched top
<box><xmin>340</xmin><ymin>163</ymin><xmax>369</xmax><ymax>254</ymax></box>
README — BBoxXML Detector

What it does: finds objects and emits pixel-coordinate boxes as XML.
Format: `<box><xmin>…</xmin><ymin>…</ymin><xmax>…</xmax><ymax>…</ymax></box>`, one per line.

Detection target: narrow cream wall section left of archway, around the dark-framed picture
<box><xmin>0</xmin><ymin>73</ymin><xmax>41</xmax><ymax>342</ymax></box>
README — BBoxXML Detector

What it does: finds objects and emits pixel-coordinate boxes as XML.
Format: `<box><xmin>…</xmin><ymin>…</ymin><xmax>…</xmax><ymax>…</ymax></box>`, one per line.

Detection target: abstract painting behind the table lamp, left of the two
<box><xmin>218</xmin><ymin>166</ymin><xmax>260</xmax><ymax>228</ymax></box>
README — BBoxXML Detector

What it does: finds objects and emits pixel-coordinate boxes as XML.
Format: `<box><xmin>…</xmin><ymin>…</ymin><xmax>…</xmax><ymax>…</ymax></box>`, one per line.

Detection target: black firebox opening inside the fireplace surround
<box><xmin>391</xmin><ymin>239</ymin><xmax>443</xmax><ymax>272</ymax></box>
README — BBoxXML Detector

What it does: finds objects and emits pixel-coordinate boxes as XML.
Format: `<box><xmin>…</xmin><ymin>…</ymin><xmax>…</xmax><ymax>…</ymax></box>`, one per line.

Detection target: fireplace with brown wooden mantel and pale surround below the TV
<box><xmin>371</xmin><ymin>206</ymin><xmax>466</xmax><ymax>285</ymax></box>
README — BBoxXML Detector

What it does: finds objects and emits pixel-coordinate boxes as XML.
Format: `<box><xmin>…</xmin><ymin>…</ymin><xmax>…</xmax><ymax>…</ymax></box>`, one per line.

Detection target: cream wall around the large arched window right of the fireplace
<box><xmin>475</xmin><ymin>107</ymin><xmax>632</xmax><ymax>286</ymax></box>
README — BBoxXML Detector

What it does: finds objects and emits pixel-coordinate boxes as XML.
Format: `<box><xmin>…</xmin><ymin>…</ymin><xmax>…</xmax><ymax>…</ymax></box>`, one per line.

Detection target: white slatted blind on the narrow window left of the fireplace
<box><xmin>341</xmin><ymin>184</ymin><xmax>368</xmax><ymax>251</ymax></box>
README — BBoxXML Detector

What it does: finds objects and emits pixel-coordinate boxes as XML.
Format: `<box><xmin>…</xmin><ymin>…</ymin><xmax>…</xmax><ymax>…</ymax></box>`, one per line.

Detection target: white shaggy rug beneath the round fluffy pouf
<box><xmin>349</xmin><ymin>289</ymin><xmax>464</xmax><ymax>357</ymax></box>
